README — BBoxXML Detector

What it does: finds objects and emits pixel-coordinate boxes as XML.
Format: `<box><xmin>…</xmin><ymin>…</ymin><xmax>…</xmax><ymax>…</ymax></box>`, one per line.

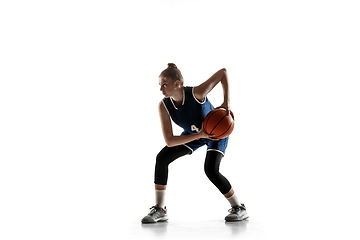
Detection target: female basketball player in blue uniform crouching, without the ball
<box><xmin>142</xmin><ymin>63</ymin><xmax>248</xmax><ymax>223</ymax></box>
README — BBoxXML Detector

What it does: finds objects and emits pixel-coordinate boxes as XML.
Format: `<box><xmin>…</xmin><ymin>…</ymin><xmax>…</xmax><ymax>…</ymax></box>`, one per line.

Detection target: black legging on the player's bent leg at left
<box><xmin>154</xmin><ymin>145</ymin><xmax>191</xmax><ymax>185</ymax></box>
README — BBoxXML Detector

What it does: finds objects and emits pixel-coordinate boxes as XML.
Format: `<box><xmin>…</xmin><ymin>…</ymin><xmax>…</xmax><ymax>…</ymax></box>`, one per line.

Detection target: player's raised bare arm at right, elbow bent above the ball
<box><xmin>194</xmin><ymin>68</ymin><xmax>230</xmax><ymax>112</ymax></box>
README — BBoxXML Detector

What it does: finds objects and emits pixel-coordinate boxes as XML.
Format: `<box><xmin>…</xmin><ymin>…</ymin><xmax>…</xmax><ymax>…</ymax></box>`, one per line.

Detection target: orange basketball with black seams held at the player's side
<box><xmin>203</xmin><ymin>108</ymin><xmax>235</xmax><ymax>139</ymax></box>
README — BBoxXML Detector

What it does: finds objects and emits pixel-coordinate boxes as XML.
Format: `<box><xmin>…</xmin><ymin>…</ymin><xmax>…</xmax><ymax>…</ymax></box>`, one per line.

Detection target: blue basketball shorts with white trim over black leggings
<box><xmin>181</xmin><ymin>132</ymin><xmax>229</xmax><ymax>155</ymax></box>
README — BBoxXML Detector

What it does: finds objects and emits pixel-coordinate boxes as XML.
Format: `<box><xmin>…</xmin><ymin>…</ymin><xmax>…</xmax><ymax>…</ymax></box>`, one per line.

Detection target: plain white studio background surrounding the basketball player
<box><xmin>0</xmin><ymin>0</ymin><xmax>360</xmax><ymax>239</ymax></box>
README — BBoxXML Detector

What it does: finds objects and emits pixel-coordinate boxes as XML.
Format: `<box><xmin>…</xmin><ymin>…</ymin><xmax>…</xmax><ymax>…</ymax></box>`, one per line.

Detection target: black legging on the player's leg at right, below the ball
<box><xmin>204</xmin><ymin>151</ymin><xmax>231</xmax><ymax>194</ymax></box>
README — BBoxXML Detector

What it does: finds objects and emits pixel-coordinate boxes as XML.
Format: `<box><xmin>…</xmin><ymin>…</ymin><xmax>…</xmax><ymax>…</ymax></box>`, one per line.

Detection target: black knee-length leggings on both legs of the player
<box><xmin>155</xmin><ymin>145</ymin><xmax>231</xmax><ymax>194</ymax></box>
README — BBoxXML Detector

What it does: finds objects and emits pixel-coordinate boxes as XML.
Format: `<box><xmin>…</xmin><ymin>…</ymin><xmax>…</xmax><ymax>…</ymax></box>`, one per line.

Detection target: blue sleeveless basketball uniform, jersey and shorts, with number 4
<box><xmin>162</xmin><ymin>87</ymin><xmax>229</xmax><ymax>154</ymax></box>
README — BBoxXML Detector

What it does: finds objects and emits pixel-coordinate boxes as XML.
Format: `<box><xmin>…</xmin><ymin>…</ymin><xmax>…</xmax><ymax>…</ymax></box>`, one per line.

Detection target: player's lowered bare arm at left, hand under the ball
<box><xmin>159</xmin><ymin>101</ymin><xmax>212</xmax><ymax>147</ymax></box>
